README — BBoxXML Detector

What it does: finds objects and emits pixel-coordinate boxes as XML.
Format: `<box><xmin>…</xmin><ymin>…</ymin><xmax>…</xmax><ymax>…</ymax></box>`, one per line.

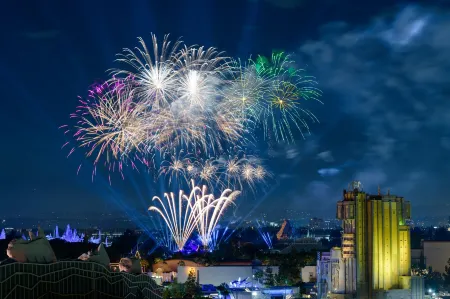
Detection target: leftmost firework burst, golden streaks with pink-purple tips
<box><xmin>61</xmin><ymin>81</ymin><xmax>146</xmax><ymax>179</ymax></box>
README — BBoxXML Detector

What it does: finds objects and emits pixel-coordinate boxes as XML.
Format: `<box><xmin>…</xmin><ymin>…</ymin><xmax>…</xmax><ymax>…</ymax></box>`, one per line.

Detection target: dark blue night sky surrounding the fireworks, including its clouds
<box><xmin>0</xmin><ymin>0</ymin><xmax>450</xmax><ymax>223</ymax></box>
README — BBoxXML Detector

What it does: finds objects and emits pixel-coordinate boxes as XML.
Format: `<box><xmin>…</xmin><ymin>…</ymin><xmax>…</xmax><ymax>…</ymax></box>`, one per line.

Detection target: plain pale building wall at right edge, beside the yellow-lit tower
<box><xmin>423</xmin><ymin>241</ymin><xmax>450</xmax><ymax>273</ymax></box>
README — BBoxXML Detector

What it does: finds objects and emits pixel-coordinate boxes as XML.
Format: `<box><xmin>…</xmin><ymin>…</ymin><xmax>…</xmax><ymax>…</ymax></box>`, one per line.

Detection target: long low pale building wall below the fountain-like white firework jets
<box><xmin>177</xmin><ymin>266</ymin><xmax>279</xmax><ymax>286</ymax></box>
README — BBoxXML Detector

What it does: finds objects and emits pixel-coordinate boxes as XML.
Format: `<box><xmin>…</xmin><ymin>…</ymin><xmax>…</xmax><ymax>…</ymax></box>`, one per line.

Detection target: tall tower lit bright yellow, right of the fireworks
<box><xmin>337</xmin><ymin>182</ymin><xmax>411</xmax><ymax>298</ymax></box>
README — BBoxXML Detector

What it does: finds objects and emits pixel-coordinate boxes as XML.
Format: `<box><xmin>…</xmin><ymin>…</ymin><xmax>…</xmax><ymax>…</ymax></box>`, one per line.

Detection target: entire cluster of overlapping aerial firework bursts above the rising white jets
<box><xmin>63</xmin><ymin>35</ymin><xmax>321</xmax><ymax>190</ymax></box>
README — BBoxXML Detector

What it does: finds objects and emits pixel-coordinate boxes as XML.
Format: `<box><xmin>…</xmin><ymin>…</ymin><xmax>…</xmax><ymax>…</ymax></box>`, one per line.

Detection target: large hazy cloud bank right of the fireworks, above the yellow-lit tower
<box><xmin>297</xmin><ymin>6</ymin><xmax>450</xmax><ymax>212</ymax></box>
